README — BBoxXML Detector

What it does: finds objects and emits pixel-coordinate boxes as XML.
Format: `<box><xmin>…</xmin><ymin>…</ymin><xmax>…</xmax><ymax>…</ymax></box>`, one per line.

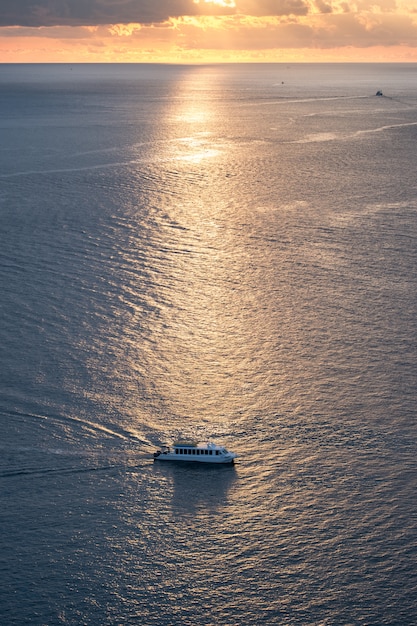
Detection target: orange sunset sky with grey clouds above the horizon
<box><xmin>0</xmin><ymin>0</ymin><xmax>417</xmax><ymax>64</ymax></box>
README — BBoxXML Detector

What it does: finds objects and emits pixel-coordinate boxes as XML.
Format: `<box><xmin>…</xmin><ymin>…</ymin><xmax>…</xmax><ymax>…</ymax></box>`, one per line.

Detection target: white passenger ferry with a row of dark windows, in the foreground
<box><xmin>153</xmin><ymin>441</ymin><xmax>237</xmax><ymax>464</ymax></box>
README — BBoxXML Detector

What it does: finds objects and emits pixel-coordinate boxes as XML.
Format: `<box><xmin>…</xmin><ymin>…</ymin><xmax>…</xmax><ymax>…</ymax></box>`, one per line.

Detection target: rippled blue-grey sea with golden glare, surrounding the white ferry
<box><xmin>0</xmin><ymin>64</ymin><xmax>417</xmax><ymax>626</ymax></box>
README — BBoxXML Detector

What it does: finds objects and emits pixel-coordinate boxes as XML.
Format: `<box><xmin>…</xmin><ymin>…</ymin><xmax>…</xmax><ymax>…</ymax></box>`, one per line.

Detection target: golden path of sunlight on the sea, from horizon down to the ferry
<box><xmin>117</xmin><ymin>68</ymin><xmax>292</xmax><ymax>438</ymax></box>
